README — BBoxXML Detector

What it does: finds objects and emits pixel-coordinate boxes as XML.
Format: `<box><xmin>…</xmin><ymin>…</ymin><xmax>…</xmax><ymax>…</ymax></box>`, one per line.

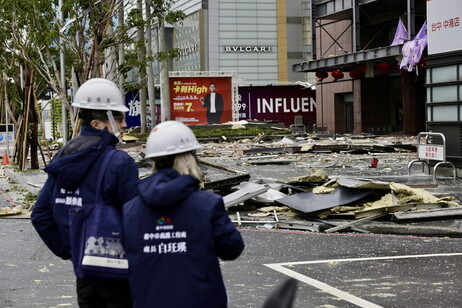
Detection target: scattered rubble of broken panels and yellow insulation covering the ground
<box><xmin>6</xmin><ymin>128</ymin><xmax>462</xmax><ymax>238</ymax></box>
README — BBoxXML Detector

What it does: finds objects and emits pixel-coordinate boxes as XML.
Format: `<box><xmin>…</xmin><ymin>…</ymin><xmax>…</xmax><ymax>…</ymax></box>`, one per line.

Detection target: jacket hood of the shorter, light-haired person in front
<box><xmin>138</xmin><ymin>169</ymin><xmax>199</xmax><ymax>208</ymax></box>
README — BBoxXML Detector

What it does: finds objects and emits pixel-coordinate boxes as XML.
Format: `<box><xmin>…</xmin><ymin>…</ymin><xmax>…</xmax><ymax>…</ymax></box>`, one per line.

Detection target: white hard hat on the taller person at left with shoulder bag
<box><xmin>72</xmin><ymin>78</ymin><xmax>129</xmax><ymax>112</ymax></box>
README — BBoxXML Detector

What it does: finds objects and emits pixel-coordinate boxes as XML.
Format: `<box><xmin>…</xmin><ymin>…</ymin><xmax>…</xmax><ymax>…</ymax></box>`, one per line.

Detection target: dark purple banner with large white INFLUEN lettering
<box><xmin>239</xmin><ymin>86</ymin><xmax>316</xmax><ymax>127</ymax></box>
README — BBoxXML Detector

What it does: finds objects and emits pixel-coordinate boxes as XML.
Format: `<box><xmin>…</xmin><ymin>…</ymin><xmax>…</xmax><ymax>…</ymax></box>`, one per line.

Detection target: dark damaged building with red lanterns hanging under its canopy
<box><xmin>293</xmin><ymin>0</ymin><xmax>426</xmax><ymax>134</ymax></box>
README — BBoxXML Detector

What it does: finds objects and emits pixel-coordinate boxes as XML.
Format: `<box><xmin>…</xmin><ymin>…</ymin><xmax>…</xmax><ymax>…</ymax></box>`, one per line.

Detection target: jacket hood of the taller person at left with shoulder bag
<box><xmin>45</xmin><ymin>126</ymin><xmax>118</xmax><ymax>190</ymax></box>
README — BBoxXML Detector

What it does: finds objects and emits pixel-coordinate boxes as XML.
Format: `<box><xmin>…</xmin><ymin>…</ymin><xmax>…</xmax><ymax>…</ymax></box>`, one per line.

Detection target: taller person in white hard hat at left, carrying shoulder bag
<box><xmin>31</xmin><ymin>78</ymin><xmax>139</xmax><ymax>308</ymax></box>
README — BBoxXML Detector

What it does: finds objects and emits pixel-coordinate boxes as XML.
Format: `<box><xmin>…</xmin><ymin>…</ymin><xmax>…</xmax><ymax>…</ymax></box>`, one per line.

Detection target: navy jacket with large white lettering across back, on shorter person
<box><xmin>123</xmin><ymin>169</ymin><xmax>244</xmax><ymax>308</ymax></box>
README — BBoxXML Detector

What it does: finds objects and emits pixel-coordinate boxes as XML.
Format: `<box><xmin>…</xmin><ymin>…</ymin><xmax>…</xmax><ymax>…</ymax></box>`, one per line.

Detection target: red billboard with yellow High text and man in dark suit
<box><xmin>170</xmin><ymin>77</ymin><xmax>233</xmax><ymax>125</ymax></box>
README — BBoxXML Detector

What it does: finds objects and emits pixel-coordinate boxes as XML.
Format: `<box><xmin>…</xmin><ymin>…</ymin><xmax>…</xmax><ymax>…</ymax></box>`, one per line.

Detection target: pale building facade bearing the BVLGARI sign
<box><xmin>171</xmin><ymin>0</ymin><xmax>312</xmax><ymax>84</ymax></box>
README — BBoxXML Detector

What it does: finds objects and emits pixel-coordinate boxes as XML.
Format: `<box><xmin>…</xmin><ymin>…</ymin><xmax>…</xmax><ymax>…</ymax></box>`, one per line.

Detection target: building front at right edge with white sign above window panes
<box><xmin>426</xmin><ymin>0</ymin><xmax>462</xmax><ymax>162</ymax></box>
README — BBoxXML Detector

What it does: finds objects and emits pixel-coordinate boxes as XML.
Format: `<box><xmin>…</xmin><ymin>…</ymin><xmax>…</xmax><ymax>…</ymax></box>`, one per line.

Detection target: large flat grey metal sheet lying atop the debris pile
<box><xmin>275</xmin><ymin>186</ymin><xmax>375</xmax><ymax>213</ymax></box>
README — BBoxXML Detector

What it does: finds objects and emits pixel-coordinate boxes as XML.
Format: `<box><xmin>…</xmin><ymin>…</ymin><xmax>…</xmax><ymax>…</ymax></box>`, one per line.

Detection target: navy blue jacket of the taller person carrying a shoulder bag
<box><xmin>31</xmin><ymin>126</ymin><xmax>139</xmax><ymax>259</ymax></box>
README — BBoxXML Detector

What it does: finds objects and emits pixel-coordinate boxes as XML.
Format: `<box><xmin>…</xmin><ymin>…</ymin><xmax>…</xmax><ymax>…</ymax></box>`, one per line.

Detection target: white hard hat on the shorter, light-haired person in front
<box><xmin>146</xmin><ymin>121</ymin><xmax>202</xmax><ymax>158</ymax></box>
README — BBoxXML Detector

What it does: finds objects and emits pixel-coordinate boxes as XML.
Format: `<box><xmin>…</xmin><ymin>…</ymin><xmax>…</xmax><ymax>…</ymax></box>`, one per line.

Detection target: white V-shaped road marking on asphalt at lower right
<box><xmin>264</xmin><ymin>253</ymin><xmax>462</xmax><ymax>308</ymax></box>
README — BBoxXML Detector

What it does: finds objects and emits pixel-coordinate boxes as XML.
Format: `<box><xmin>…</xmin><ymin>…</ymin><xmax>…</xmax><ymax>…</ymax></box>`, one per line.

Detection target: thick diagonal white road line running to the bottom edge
<box><xmin>265</xmin><ymin>264</ymin><xmax>382</xmax><ymax>308</ymax></box>
